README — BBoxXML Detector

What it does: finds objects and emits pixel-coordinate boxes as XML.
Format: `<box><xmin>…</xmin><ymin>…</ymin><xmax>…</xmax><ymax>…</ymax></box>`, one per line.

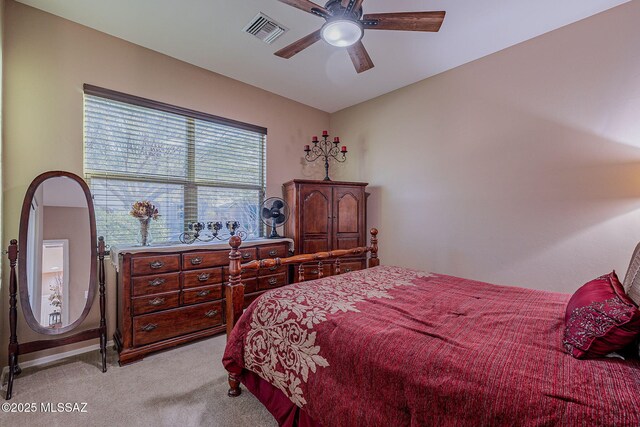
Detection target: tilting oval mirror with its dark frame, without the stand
<box><xmin>18</xmin><ymin>171</ymin><xmax>97</xmax><ymax>335</ymax></box>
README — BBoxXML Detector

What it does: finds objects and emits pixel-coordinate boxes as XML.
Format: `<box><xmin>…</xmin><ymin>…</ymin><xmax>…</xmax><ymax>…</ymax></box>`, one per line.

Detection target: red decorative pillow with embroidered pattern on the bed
<box><xmin>563</xmin><ymin>271</ymin><xmax>640</xmax><ymax>359</ymax></box>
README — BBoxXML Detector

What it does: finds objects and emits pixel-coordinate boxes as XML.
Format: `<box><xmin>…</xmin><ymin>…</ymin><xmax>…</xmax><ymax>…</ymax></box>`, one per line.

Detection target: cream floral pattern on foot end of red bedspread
<box><xmin>244</xmin><ymin>267</ymin><xmax>430</xmax><ymax>407</ymax></box>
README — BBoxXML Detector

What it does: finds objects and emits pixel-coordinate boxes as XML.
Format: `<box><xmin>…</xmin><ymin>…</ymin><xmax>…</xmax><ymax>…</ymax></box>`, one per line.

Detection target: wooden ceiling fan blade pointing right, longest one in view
<box><xmin>362</xmin><ymin>12</ymin><xmax>446</xmax><ymax>32</ymax></box>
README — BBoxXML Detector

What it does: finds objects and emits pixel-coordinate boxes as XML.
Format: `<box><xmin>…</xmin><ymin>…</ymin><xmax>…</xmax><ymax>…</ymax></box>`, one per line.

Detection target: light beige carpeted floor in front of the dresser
<box><xmin>0</xmin><ymin>335</ymin><xmax>277</xmax><ymax>427</ymax></box>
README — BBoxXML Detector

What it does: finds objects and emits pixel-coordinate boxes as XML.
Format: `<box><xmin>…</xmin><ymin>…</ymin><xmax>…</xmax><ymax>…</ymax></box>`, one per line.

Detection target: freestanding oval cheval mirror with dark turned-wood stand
<box><xmin>5</xmin><ymin>171</ymin><xmax>107</xmax><ymax>400</ymax></box>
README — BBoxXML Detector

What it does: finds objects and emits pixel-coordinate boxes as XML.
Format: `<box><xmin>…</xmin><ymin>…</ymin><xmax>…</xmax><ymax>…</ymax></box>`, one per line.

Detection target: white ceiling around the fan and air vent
<box><xmin>19</xmin><ymin>0</ymin><xmax>629</xmax><ymax>112</ymax></box>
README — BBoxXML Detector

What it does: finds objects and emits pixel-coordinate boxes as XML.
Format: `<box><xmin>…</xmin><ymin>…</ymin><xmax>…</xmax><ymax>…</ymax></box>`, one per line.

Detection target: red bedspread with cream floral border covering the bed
<box><xmin>223</xmin><ymin>267</ymin><xmax>640</xmax><ymax>426</ymax></box>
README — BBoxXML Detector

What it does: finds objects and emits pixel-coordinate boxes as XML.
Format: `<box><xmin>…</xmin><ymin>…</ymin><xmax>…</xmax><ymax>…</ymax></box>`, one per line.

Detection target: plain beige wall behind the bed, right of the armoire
<box><xmin>331</xmin><ymin>2</ymin><xmax>640</xmax><ymax>292</ymax></box>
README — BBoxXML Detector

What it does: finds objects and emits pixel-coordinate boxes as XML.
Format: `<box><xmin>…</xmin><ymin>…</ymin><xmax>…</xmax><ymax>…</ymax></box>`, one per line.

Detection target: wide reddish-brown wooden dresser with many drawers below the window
<box><xmin>114</xmin><ymin>239</ymin><xmax>290</xmax><ymax>365</ymax></box>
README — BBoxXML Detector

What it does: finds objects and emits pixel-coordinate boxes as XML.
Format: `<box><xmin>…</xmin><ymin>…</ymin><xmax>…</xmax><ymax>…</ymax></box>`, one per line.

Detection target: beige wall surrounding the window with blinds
<box><xmin>0</xmin><ymin>0</ymin><xmax>329</xmax><ymax>365</ymax></box>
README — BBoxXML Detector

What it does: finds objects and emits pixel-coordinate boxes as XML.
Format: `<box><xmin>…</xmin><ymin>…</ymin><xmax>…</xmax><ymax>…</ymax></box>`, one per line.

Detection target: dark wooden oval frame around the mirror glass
<box><xmin>18</xmin><ymin>171</ymin><xmax>98</xmax><ymax>335</ymax></box>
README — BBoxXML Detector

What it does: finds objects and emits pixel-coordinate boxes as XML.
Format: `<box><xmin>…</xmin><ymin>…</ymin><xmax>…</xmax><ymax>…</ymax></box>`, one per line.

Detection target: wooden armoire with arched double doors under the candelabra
<box><xmin>283</xmin><ymin>179</ymin><xmax>367</xmax><ymax>278</ymax></box>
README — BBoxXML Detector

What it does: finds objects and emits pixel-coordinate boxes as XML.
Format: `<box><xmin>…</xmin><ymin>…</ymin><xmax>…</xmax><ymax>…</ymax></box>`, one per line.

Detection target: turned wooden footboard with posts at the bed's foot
<box><xmin>225</xmin><ymin>228</ymin><xmax>380</xmax><ymax>336</ymax></box>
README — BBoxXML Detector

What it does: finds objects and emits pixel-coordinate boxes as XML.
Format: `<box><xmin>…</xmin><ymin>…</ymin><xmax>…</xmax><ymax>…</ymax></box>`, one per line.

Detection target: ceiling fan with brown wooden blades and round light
<box><xmin>275</xmin><ymin>0</ymin><xmax>446</xmax><ymax>73</ymax></box>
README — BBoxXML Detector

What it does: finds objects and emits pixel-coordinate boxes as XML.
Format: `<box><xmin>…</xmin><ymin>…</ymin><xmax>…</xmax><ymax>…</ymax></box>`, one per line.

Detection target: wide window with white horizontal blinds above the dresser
<box><xmin>84</xmin><ymin>85</ymin><xmax>267</xmax><ymax>245</ymax></box>
